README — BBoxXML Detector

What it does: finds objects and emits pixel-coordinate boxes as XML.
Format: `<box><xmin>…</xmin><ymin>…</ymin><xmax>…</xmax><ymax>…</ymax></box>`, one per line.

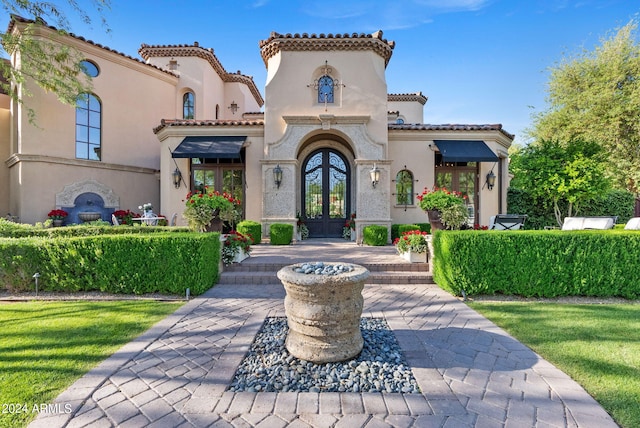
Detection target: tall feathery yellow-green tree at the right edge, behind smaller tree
<box><xmin>528</xmin><ymin>20</ymin><xmax>640</xmax><ymax>197</ymax></box>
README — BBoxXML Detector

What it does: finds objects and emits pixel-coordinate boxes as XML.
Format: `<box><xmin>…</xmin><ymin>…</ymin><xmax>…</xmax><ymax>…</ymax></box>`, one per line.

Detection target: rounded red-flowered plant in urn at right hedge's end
<box><xmin>417</xmin><ymin>187</ymin><xmax>469</xmax><ymax>230</ymax></box>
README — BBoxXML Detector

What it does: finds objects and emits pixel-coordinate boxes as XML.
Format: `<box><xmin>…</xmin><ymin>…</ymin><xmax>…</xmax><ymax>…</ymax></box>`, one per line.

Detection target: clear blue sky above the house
<box><xmin>0</xmin><ymin>0</ymin><xmax>640</xmax><ymax>143</ymax></box>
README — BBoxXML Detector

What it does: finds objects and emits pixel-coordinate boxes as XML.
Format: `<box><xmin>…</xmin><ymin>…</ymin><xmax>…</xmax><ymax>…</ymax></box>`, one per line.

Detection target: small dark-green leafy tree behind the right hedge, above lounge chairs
<box><xmin>510</xmin><ymin>140</ymin><xmax>610</xmax><ymax>225</ymax></box>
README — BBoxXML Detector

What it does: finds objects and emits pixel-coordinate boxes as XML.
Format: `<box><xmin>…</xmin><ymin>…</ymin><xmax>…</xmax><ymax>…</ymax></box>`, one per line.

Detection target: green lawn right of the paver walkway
<box><xmin>469</xmin><ymin>302</ymin><xmax>640</xmax><ymax>428</ymax></box>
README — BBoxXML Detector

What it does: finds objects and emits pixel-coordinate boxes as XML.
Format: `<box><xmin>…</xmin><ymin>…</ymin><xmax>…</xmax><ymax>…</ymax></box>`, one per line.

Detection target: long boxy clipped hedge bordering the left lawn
<box><xmin>0</xmin><ymin>233</ymin><xmax>220</xmax><ymax>295</ymax></box>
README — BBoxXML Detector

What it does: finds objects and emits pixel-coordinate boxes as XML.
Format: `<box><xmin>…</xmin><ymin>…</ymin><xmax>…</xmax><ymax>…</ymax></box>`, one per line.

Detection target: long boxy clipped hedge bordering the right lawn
<box><xmin>433</xmin><ymin>230</ymin><xmax>640</xmax><ymax>299</ymax></box>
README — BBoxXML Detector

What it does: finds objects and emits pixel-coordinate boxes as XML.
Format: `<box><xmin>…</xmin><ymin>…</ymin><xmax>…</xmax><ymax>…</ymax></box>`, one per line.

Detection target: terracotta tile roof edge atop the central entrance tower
<box><xmin>259</xmin><ymin>31</ymin><xmax>395</xmax><ymax>66</ymax></box>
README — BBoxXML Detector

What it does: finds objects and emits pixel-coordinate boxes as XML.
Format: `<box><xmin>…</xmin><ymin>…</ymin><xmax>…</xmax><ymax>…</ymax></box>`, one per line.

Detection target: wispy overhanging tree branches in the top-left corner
<box><xmin>0</xmin><ymin>0</ymin><xmax>110</xmax><ymax>123</ymax></box>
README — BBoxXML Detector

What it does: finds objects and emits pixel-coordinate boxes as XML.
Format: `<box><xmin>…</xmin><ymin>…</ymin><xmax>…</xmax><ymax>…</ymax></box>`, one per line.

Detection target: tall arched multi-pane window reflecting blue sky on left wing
<box><xmin>76</xmin><ymin>94</ymin><xmax>102</xmax><ymax>160</ymax></box>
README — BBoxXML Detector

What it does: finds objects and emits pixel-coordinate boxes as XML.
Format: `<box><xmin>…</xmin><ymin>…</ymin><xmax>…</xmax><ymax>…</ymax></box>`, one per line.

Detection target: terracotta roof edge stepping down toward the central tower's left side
<box><xmin>138</xmin><ymin>42</ymin><xmax>264</xmax><ymax>106</ymax></box>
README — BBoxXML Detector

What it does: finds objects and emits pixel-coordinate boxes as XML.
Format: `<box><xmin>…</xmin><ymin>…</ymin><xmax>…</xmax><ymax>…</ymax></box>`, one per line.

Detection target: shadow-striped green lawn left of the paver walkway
<box><xmin>0</xmin><ymin>301</ymin><xmax>183</xmax><ymax>427</ymax></box>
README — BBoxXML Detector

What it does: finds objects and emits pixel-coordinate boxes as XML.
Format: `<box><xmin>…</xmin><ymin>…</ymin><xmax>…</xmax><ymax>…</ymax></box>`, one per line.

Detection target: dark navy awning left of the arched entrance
<box><xmin>171</xmin><ymin>136</ymin><xmax>247</xmax><ymax>159</ymax></box>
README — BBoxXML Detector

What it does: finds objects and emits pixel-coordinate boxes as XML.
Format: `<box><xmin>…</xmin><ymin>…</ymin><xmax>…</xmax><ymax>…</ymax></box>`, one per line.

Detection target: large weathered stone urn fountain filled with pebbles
<box><xmin>278</xmin><ymin>262</ymin><xmax>369</xmax><ymax>364</ymax></box>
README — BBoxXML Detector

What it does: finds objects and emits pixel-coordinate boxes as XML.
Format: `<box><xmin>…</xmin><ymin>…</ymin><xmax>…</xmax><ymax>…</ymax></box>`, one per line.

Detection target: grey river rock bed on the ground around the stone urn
<box><xmin>228</xmin><ymin>317</ymin><xmax>420</xmax><ymax>393</ymax></box>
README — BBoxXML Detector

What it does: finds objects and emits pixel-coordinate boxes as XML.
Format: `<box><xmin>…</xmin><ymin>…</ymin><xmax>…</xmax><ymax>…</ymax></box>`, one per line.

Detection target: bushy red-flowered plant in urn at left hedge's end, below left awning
<box><xmin>184</xmin><ymin>186</ymin><xmax>240</xmax><ymax>232</ymax></box>
